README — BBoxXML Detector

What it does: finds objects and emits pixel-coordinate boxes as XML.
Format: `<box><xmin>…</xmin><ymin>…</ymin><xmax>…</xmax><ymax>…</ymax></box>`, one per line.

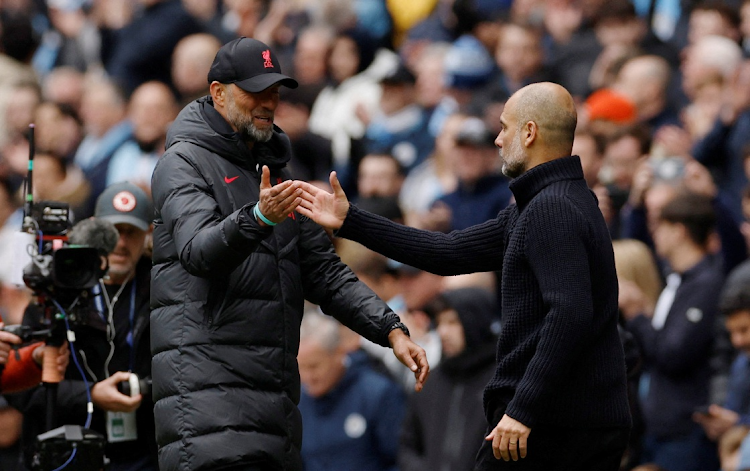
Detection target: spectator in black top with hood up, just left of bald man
<box><xmin>398</xmin><ymin>288</ymin><xmax>499</xmax><ymax>471</ymax></box>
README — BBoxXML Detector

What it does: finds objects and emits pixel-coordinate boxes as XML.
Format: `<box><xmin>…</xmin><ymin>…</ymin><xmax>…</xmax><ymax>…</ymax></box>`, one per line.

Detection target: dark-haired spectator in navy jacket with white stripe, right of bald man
<box><xmin>623</xmin><ymin>194</ymin><xmax>724</xmax><ymax>471</ymax></box>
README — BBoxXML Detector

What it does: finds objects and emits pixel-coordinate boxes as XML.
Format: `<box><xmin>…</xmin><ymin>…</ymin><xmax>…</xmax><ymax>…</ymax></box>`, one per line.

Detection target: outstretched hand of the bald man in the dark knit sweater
<box><xmin>297</xmin><ymin>172</ymin><xmax>349</xmax><ymax>230</ymax></box>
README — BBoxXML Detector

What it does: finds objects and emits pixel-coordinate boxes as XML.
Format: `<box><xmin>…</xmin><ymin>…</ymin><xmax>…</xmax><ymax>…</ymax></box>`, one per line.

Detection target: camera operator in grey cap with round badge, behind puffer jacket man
<box><xmin>11</xmin><ymin>182</ymin><xmax>158</xmax><ymax>471</ymax></box>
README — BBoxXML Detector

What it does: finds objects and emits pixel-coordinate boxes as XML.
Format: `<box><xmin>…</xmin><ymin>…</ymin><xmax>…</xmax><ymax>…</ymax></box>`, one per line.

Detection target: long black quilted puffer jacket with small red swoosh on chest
<box><xmin>151</xmin><ymin>97</ymin><xmax>398</xmax><ymax>471</ymax></box>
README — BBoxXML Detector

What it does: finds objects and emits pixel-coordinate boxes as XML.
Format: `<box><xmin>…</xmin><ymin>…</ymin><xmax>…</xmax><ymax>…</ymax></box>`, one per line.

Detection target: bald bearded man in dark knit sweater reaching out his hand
<box><xmin>297</xmin><ymin>83</ymin><xmax>631</xmax><ymax>471</ymax></box>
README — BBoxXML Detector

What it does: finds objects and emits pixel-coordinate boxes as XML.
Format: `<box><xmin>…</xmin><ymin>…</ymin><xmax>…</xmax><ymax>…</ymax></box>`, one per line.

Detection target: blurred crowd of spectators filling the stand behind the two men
<box><xmin>0</xmin><ymin>0</ymin><xmax>750</xmax><ymax>471</ymax></box>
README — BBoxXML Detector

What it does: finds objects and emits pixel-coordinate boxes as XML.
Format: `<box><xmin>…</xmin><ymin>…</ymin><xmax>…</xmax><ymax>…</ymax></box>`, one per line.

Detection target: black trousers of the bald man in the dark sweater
<box><xmin>474</xmin><ymin>408</ymin><xmax>630</xmax><ymax>471</ymax></box>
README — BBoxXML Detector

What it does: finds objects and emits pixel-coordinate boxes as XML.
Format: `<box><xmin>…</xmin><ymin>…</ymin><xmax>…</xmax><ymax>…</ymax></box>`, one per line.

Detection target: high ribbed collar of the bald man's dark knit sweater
<box><xmin>509</xmin><ymin>155</ymin><xmax>583</xmax><ymax>208</ymax></box>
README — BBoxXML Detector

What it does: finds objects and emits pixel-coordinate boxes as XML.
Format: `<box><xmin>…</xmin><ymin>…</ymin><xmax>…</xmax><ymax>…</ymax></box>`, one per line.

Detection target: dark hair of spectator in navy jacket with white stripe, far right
<box><xmin>659</xmin><ymin>192</ymin><xmax>716</xmax><ymax>247</ymax></box>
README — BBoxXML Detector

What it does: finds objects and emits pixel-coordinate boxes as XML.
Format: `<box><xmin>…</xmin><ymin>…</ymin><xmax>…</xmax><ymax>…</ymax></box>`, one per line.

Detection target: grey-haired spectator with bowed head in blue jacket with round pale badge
<box><xmin>298</xmin><ymin>312</ymin><xmax>405</xmax><ymax>471</ymax></box>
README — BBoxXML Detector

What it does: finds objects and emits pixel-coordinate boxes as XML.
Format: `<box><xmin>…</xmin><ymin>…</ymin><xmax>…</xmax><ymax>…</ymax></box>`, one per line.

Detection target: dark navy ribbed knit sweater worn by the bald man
<box><xmin>336</xmin><ymin>156</ymin><xmax>630</xmax><ymax>428</ymax></box>
